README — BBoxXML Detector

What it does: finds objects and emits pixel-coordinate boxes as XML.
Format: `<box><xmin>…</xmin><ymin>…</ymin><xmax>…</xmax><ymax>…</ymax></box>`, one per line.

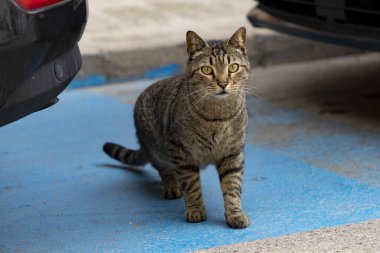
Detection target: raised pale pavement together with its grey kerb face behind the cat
<box><xmin>75</xmin><ymin>0</ymin><xmax>361</xmax><ymax>88</ymax></box>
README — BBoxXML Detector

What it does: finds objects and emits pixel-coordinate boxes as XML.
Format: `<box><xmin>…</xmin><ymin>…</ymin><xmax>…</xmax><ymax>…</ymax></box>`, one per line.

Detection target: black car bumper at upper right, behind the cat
<box><xmin>248</xmin><ymin>0</ymin><xmax>380</xmax><ymax>51</ymax></box>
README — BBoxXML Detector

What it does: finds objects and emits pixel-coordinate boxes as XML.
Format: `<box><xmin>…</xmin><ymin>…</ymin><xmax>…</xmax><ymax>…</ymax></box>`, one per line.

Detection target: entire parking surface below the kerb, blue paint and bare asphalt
<box><xmin>0</xmin><ymin>54</ymin><xmax>380</xmax><ymax>252</ymax></box>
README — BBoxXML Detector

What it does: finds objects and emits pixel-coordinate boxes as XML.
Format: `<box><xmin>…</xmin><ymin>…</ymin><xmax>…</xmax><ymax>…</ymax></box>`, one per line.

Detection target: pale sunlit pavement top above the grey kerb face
<box><xmin>80</xmin><ymin>0</ymin><xmax>255</xmax><ymax>55</ymax></box>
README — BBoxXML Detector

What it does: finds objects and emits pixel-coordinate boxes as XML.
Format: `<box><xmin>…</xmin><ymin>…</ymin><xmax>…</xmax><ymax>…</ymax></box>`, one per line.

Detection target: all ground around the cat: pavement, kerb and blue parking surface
<box><xmin>0</xmin><ymin>0</ymin><xmax>380</xmax><ymax>253</ymax></box>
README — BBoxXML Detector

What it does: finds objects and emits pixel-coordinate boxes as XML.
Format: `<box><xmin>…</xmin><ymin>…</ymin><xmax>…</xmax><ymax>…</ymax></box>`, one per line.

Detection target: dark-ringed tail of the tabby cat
<box><xmin>103</xmin><ymin>142</ymin><xmax>148</xmax><ymax>166</ymax></box>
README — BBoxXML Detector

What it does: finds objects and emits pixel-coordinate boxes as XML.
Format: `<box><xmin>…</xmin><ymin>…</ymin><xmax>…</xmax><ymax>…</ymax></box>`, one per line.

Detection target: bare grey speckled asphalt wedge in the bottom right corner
<box><xmin>197</xmin><ymin>220</ymin><xmax>380</xmax><ymax>253</ymax></box>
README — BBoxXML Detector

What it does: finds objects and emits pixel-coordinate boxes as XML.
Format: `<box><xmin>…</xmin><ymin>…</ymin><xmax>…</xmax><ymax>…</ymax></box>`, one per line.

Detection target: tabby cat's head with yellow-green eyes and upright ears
<box><xmin>186</xmin><ymin>27</ymin><xmax>249</xmax><ymax>98</ymax></box>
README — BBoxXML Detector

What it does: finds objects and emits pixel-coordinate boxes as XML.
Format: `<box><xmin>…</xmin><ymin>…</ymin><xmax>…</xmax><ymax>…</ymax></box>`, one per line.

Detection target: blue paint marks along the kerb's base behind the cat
<box><xmin>68</xmin><ymin>63</ymin><xmax>181</xmax><ymax>89</ymax></box>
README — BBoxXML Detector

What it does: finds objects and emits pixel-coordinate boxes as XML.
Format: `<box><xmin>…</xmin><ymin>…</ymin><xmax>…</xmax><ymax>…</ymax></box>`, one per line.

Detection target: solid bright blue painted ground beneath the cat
<box><xmin>0</xmin><ymin>87</ymin><xmax>380</xmax><ymax>253</ymax></box>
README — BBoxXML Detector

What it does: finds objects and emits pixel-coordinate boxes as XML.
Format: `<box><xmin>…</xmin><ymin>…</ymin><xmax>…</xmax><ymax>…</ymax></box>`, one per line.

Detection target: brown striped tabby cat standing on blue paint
<box><xmin>103</xmin><ymin>27</ymin><xmax>250</xmax><ymax>228</ymax></box>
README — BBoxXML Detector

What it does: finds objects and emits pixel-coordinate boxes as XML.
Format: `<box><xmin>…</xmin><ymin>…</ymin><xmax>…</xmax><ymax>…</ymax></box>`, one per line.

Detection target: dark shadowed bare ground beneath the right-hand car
<box><xmin>251</xmin><ymin>53</ymin><xmax>380</xmax><ymax>130</ymax></box>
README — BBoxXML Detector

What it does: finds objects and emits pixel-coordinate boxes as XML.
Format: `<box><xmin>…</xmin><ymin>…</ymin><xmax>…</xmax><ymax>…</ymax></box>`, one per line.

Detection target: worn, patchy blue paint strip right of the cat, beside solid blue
<box><xmin>248</xmin><ymin>99</ymin><xmax>380</xmax><ymax>188</ymax></box>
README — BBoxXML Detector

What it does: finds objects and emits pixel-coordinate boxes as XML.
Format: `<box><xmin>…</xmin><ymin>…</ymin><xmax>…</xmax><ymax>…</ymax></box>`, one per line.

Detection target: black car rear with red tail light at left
<box><xmin>0</xmin><ymin>0</ymin><xmax>88</xmax><ymax>126</ymax></box>
